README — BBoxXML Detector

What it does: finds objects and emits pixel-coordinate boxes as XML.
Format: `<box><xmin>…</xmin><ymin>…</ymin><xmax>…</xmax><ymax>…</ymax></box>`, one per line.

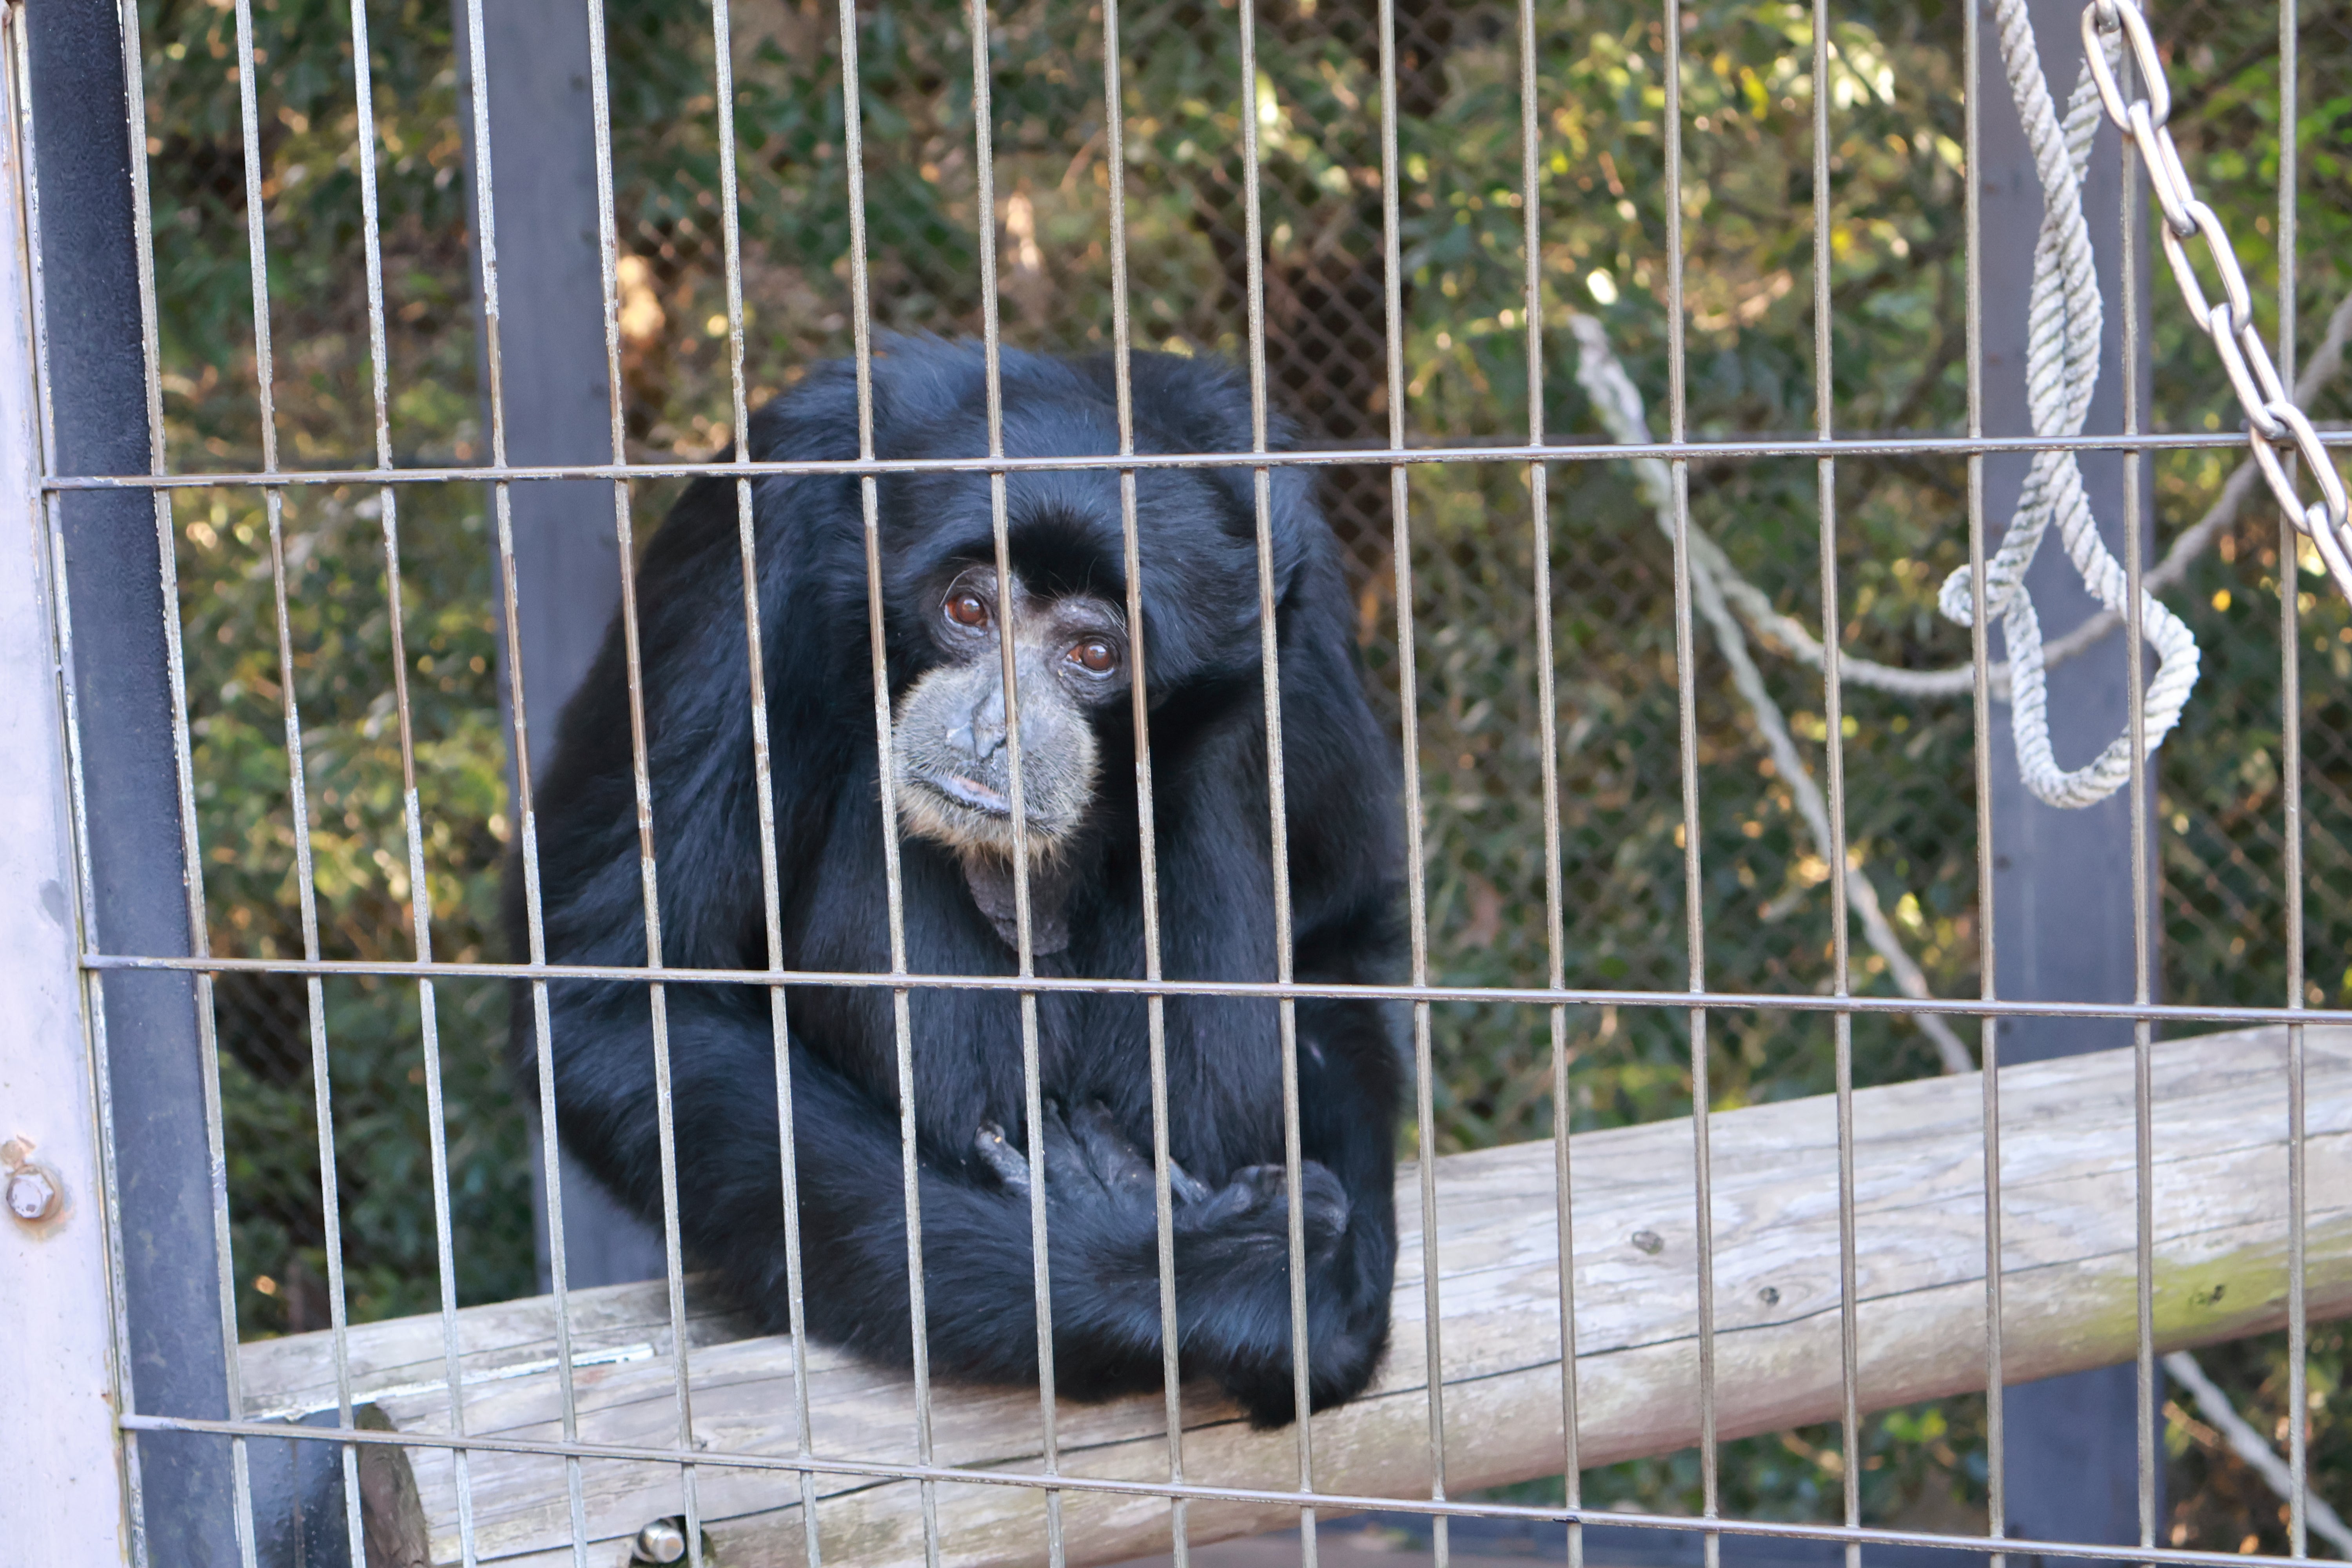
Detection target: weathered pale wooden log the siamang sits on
<box><xmin>242</xmin><ymin>1027</ymin><xmax>2352</xmax><ymax>1568</ymax></box>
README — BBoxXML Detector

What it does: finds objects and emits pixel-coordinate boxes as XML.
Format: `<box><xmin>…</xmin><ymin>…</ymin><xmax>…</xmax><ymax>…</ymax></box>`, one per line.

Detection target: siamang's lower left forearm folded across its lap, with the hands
<box><xmin>550</xmin><ymin>964</ymin><xmax>1395</xmax><ymax>1425</ymax></box>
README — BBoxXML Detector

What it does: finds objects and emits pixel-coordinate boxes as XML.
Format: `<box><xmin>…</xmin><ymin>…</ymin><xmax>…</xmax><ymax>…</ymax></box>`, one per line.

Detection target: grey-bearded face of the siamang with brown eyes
<box><xmin>891</xmin><ymin>566</ymin><xmax>1127</xmax><ymax>860</ymax></box>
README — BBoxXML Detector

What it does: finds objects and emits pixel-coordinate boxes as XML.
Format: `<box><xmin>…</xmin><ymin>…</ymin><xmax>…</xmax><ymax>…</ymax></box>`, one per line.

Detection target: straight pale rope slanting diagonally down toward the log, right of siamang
<box><xmin>1569</xmin><ymin>313</ymin><xmax>1976</xmax><ymax>1072</ymax></box>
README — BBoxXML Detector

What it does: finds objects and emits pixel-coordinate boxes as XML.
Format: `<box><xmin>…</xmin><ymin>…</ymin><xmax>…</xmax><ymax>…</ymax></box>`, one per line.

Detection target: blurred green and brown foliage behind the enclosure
<box><xmin>141</xmin><ymin>0</ymin><xmax>2352</xmax><ymax>1552</ymax></box>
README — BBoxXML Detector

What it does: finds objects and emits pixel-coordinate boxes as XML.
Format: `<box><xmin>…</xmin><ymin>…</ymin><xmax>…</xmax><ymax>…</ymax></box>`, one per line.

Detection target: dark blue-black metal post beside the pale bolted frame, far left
<box><xmin>24</xmin><ymin>0</ymin><xmax>238</xmax><ymax>1566</ymax></box>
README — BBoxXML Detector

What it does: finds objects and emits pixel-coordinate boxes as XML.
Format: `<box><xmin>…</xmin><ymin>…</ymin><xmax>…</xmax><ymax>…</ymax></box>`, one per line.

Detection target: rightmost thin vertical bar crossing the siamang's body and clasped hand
<box><xmin>1235</xmin><ymin>0</ymin><xmax>1317</xmax><ymax>1568</ymax></box>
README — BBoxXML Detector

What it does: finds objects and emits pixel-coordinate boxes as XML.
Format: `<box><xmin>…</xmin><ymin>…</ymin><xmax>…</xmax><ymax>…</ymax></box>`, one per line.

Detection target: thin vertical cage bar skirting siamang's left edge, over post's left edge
<box><xmin>461</xmin><ymin>0</ymin><xmax>604</xmax><ymax>1568</ymax></box>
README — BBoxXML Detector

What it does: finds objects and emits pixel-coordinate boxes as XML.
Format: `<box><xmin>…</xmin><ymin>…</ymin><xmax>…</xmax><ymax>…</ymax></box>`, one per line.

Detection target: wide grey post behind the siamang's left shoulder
<box><xmin>456</xmin><ymin>0</ymin><xmax>663</xmax><ymax>1286</ymax></box>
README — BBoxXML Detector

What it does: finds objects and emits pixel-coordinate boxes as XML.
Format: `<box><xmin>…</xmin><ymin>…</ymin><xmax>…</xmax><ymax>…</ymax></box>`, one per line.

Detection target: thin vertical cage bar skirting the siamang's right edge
<box><xmin>1381</xmin><ymin>0</ymin><xmax>1451</xmax><ymax>1568</ymax></box>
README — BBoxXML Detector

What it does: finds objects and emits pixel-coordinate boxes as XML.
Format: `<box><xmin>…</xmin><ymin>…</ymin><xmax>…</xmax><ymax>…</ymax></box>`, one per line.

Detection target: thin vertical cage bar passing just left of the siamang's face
<box><xmin>840</xmin><ymin>0</ymin><xmax>938</xmax><ymax>1568</ymax></box>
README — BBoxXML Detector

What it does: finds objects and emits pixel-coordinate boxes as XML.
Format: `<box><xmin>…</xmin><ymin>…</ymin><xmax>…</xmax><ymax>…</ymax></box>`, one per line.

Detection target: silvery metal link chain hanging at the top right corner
<box><xmin>2082</xmin><ymin>0</ymin><xmax>2352</xmax><ymax>599</ymax></box>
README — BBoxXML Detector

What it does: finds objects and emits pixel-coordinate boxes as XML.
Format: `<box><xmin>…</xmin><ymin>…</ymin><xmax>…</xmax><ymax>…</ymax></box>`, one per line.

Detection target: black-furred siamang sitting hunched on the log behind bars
<box><xmin>508</xmin><ymin>339</ymin><xmax>1402</xmax><ymax>1425</ymax></box>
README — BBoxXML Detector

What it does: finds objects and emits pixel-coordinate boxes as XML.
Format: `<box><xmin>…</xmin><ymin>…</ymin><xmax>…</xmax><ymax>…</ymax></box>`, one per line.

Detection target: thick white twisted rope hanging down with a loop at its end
<box><xmin>1938</xmin><ymin>15</ymin><xmax>2197</xmax><ymax>806</ymax></box>
